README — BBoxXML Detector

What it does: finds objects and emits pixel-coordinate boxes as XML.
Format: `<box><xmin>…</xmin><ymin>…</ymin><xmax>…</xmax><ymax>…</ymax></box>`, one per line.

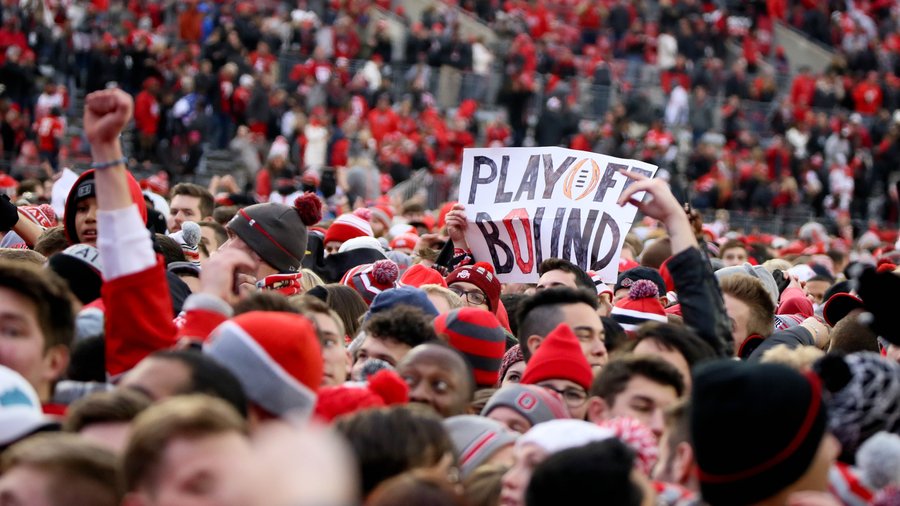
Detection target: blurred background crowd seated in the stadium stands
<box><xmin>0</xmin><ymin>0</ymin><xmax>900</xmax><ymax>228</ymax></box>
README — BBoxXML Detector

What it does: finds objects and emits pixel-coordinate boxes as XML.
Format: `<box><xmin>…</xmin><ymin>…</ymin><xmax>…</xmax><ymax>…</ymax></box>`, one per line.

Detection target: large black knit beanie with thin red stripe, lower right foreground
<box><xmin>690</xmin><ymin>360</ymin><xmax>826</xmax><ymax>506</ymax></box>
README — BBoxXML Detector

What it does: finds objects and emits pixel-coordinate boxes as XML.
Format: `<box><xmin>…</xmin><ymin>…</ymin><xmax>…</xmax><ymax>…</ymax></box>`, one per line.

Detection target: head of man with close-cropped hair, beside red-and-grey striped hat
<box><xmin>397</xmin><ymin>343</ymin><xmax>475</xmax><ymax>418</ymax></box>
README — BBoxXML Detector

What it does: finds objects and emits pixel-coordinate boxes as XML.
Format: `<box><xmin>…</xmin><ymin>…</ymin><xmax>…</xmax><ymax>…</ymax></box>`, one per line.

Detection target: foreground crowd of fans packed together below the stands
<box><xmin>0</xmin><ymin>89</ymin><xmax>900</xmax><ymax>506</ymax></box>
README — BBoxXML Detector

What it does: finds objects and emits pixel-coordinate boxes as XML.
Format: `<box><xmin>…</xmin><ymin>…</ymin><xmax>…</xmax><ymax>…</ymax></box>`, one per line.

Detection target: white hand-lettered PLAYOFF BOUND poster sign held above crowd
<box><xmin>459</xmin><ymin>147</ymin><xmax>657</xmax><ymax>283</ymax></box>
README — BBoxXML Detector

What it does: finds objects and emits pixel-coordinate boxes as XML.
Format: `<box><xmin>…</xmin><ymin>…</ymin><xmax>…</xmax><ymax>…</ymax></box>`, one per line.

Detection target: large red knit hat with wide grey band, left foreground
<box><xmin>204</xmin><ymin>311</ymin><xmax>323</xmax><ymax>416</ymax></box>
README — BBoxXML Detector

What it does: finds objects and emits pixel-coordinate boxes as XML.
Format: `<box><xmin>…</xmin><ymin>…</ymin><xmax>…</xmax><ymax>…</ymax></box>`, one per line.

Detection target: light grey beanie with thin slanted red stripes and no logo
<box><xmin>444</xmin><ymin>415</ymin><xmax>518</xmax><ymax>478</ymax></box>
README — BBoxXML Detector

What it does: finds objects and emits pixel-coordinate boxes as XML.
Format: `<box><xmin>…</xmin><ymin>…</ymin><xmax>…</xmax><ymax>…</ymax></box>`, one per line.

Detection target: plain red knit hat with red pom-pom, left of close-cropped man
<box><xmin>315</xmin><ymin>369</ymin><xmax>409</xmax><ymax>422</ymax></box>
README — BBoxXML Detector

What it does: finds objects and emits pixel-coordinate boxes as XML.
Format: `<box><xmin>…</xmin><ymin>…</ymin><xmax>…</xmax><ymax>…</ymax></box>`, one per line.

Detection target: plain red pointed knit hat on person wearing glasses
<box><xmin>522</xmin><ymin>323</ymin><xmax>594</xmax><ymax>390</ymax></box>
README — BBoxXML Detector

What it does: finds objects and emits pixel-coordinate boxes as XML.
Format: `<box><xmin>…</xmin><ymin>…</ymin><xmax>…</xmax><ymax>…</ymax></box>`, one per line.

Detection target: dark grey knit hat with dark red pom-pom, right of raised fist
<box><xmin>228</xmin><ymin>193</ymin><xmax>322</xmax><ymax>273</ymax></box>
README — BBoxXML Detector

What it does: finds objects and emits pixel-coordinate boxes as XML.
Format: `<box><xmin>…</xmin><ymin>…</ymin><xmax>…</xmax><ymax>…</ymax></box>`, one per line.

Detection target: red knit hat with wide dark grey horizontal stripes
<box><xmin>434</xmin><ymin>307</ymin><xmax>506</xmax><ymax>388</ymax></box>
